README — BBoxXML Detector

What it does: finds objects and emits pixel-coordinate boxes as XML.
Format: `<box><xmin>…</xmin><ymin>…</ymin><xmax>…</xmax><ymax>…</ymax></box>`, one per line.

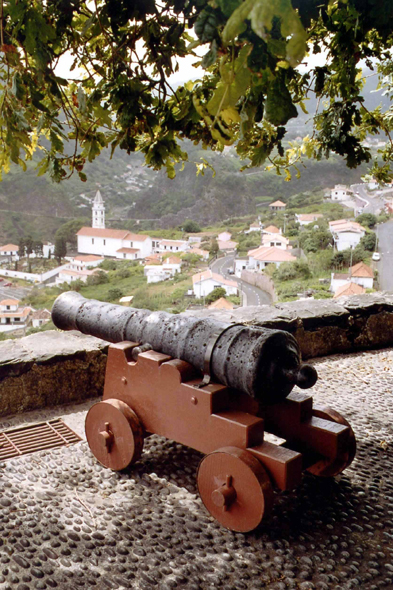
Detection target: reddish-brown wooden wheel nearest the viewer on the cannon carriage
<box><xmin>198</xmin><ymin>447</ymin><xmax>273</xmax><ymax>533</ymax></box>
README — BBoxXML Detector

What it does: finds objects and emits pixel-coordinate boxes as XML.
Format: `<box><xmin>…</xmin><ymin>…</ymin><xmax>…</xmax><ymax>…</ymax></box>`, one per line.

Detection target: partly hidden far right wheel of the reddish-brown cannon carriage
<box><xmin>307</xmin><ymin>406</ymin><xmax>356</xmax><ymax>477</ymax></box>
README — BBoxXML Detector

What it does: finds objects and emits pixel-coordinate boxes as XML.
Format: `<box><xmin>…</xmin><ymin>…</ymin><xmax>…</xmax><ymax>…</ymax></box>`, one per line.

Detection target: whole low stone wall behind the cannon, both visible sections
<box><xmin>0</xmin><ymin>293</ymin><xmax>393</xmax><ymax>416</ymax></box>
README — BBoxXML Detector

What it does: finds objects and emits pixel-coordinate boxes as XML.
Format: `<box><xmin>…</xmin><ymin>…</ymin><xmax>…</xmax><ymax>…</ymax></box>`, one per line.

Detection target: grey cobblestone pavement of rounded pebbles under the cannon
<box><xmin>0</xmin><ymin>349</ymin><xmax>393</xmax><ymax>590</ymax></box>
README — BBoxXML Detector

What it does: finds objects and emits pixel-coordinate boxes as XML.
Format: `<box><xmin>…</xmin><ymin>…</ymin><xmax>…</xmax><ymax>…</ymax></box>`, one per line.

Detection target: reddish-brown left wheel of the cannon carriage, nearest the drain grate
<box><xmin>85</xmin><ymin>399</ymin><xmax>143</xmax><ymax>471</ymax></box>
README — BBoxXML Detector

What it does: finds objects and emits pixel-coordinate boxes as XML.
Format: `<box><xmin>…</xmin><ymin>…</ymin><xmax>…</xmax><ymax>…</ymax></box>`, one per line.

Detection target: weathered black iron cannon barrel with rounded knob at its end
<box><xmin>52</xmin><ymin>291</ymin><xmax>317</xmax><ymax>404</ymax></box>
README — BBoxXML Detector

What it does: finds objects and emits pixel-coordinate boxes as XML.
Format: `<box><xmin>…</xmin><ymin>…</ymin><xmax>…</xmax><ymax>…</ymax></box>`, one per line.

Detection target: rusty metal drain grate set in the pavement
<box><xmin>0</xmin><ymin>418</ymin><xmax>82</xmax><ymax>461</ymax></box>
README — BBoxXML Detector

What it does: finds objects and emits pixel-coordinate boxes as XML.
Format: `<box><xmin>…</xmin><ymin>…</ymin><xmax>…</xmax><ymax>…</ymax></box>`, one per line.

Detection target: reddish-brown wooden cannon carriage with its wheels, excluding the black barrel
<box><xmin>86</xmin><ymin>342</ymin><xmax>356</xmax><ymax>532</ymax></box>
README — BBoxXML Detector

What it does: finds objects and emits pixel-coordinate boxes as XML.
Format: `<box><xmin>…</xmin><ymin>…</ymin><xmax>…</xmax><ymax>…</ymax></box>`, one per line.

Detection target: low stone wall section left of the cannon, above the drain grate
<box><xmin>0</xmin><ymin>331</ymin><xmax>108</xmax><ymax>416</ymax></box>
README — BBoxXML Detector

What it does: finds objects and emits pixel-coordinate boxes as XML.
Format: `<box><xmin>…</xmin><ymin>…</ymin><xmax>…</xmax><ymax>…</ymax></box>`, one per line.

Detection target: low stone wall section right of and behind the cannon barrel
<box><xmin>186</xmin><ymin>292</ymin><xmax>393</xmax><ymax>359</ymax></box>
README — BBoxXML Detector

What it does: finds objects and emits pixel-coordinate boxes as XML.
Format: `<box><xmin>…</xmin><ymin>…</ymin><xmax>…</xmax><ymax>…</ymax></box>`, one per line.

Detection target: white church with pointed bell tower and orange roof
<box><xmin>76</xmin><ymin>191</ymin><xmax>153</xmax><ymax>260</ymax></box>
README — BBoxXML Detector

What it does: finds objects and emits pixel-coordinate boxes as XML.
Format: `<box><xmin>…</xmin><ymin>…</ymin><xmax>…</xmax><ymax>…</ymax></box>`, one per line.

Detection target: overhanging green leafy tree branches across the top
<box><xmin>0</xmin><ymin>0</ymin><xmax>393</xmax><ymax>181</ymax></box>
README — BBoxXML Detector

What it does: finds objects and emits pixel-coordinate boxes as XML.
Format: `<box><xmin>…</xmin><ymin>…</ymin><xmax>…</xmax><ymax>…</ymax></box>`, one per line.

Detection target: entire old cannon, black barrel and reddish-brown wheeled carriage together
<box><xmin>52</xmin><ymin>292</ymin><xmax>356</xmax><ymax>532</ymax></box>
